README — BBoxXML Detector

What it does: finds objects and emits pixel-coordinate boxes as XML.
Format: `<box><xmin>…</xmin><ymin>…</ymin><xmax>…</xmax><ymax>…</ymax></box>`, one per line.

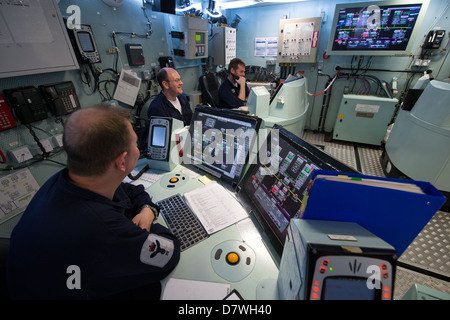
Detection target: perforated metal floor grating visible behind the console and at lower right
<box><xmin>302</xmin><ymin>130</ymin><xmax>450</xmax><ymax>298</ymax></box>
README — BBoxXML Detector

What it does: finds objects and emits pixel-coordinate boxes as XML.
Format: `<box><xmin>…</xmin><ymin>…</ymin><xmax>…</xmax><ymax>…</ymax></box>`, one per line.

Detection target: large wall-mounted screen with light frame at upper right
<box><xmin>327</xmin><ymin>0</ymin><xmax>429</xmax><ymax>56</ymax></box>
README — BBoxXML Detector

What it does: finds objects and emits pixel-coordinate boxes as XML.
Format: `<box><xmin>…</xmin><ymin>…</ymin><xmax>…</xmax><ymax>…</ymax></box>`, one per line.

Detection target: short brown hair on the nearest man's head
<box><xmin>63</xmin><ymin>104</ymin><xmax>132</xmax><ymax>176</ymax></box>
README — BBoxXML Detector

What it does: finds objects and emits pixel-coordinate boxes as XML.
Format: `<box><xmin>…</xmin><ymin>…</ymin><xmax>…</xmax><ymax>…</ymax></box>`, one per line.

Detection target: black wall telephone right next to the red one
<box><xmin>3</xmin><ymin>86</ymin><xmax>48</xmax><ymax>124</ymax></box>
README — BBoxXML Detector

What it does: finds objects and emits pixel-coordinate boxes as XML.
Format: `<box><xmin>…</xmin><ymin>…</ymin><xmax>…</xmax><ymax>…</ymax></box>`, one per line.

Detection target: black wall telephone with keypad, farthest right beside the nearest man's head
<box><xmin>39</xmin><ymin>81</ymin><xmax>81</xmax><ymax>116</ymax></box>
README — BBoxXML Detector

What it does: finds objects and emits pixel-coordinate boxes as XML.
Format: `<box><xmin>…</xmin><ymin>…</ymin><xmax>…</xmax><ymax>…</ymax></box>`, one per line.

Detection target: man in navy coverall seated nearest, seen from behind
<box><xmin>8</xmin><ymin>105</ymin><xmax>180</xmax><ymax>299</ymax></box>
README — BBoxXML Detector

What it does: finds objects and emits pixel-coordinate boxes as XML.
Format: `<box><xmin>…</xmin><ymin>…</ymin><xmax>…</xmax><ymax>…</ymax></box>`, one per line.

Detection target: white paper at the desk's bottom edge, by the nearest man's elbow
<box><xmin>162</xmin><ymin>278</ymin><xmax>230</xmax><ymax>300</ymax></box>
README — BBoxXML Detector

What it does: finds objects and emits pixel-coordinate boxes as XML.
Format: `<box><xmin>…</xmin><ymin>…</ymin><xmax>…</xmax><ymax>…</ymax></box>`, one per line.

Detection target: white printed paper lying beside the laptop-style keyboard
<box><xmin>184</xmin><ymin>182</ymin><xmax>248</xmax><ymax>234</ymax></box>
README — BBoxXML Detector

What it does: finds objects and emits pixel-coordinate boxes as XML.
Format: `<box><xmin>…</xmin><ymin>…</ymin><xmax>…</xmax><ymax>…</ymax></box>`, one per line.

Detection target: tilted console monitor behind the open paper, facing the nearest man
<box><xmin>188</xmin><ymin>106</ymin><xmax>261</xmax><ymax>188</ymax></box>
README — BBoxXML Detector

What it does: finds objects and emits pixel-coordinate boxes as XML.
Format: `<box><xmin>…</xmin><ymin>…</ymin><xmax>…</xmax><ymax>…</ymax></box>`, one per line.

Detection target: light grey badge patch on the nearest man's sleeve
<box><xmin>140</xmin><ymin>233</ymin><xmax>174</xmax><ymax>268</ymax></box>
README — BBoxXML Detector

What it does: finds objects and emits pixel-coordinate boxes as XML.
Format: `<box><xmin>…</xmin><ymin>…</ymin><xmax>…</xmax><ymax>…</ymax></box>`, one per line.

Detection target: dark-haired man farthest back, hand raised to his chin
<box><xmin>219</xmin><ymin>58</ymin><xmax>250</xmax><ymax>109</ymax></box>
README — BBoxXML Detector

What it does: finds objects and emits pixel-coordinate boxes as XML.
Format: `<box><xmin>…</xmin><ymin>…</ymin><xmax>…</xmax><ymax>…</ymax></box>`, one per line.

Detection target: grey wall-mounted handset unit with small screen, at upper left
<box><xmin>67</xmin><ymin>24</ymin><xmax>102</xmax><ymax>63</ymax></box>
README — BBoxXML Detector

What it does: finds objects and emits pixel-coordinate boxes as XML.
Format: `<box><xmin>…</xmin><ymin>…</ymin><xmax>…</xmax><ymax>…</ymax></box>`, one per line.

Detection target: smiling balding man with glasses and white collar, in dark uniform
<box><xmin>147</xmin><ymin>68</ymin><xmax>193</xmax><ymax>126</ymax></box>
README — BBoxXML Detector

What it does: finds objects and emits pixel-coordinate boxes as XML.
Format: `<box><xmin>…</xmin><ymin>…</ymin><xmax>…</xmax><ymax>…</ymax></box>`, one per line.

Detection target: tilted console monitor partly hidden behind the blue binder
<box><xmin>237</xmin><ymin>125</ymin><xmax>356</xmax><ymax>254</ymax></box>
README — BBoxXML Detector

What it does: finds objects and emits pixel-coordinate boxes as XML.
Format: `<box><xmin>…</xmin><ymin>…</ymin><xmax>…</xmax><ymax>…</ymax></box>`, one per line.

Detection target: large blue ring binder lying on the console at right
<box><xmin>300</xmin><ymin>170</ymin><xmax>446</xmax><ymax>256</ymax></box>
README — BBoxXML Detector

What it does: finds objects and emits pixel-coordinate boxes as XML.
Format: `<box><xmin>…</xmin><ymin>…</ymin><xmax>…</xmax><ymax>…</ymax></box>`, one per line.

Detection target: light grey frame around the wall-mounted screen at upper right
<box><xmin>326</xmin><ymin>0</ymin><xmax>430</xmax><ymax>57</ymax></box>
